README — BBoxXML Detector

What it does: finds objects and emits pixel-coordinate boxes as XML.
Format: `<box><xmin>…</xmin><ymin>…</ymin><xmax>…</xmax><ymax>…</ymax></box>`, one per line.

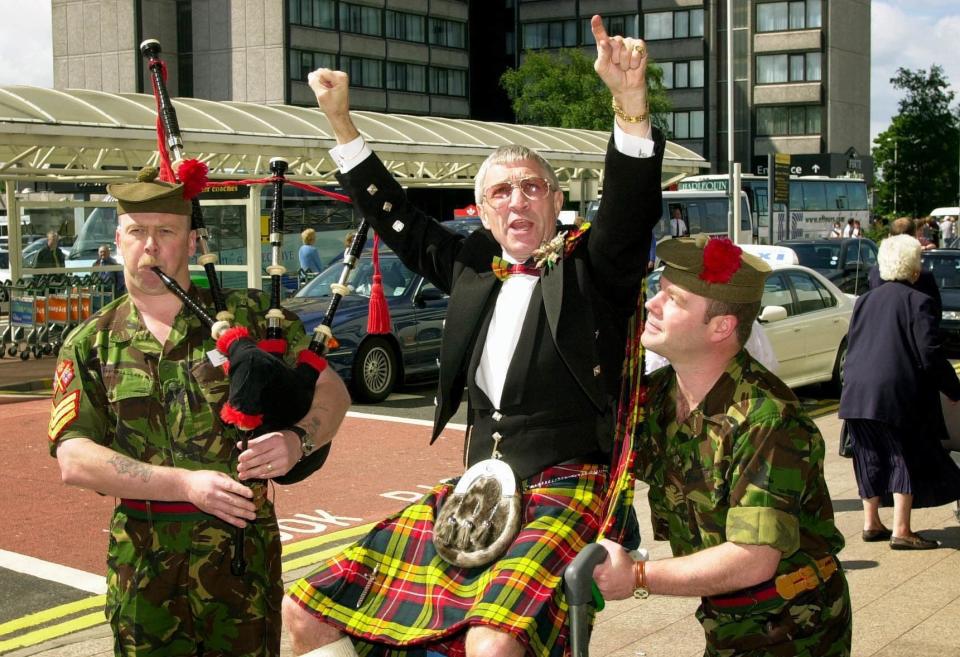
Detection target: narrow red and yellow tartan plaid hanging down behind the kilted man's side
<box><xmin>597</xmin><ymin>290</ymin><xmax>647</xmax><ymax>542</ymax></box>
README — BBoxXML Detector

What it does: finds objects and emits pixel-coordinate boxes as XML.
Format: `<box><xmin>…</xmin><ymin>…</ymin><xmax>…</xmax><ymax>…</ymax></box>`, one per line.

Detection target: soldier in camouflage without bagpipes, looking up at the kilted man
<box><xmin>594</xmin><ymin>236</ymin><xmax>852</xmax><ymax>657</ymax></box>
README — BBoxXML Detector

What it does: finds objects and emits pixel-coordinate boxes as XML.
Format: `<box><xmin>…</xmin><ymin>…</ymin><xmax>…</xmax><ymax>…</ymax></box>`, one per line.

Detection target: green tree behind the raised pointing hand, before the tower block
<box><xmin>500</xmin><ymin>48</ymin><xmax>670</xmax><ymax>131</ymax></box>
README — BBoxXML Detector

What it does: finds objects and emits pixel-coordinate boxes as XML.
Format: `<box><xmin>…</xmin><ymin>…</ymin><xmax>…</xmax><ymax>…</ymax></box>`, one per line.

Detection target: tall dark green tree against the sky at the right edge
<box><xmin>873</xmin><ymin>64</ymin><xmax>960</xmax><ymax>217</ymax></box>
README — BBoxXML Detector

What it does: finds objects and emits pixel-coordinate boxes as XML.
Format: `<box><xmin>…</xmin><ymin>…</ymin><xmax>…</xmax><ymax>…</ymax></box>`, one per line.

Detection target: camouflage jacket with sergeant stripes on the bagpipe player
<box><xmin>49</xmin><ymin>286</ymin><xmax>307</xmax><ymax>514</ymax></box>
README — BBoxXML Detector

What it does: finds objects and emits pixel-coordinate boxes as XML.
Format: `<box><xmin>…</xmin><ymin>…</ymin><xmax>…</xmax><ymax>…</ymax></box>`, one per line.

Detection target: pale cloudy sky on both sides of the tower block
<box><xmin>0</xmin><ymin>0</ymin><xmax>960</xmax><ymax>147</ymax></box>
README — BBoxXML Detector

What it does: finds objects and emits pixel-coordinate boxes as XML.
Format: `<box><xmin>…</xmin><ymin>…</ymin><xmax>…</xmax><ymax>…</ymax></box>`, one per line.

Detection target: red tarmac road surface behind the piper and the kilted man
<box><xmin>0</xmin><ymin>399</ymin><xmax>463</xmax><ymax>574</ymax></box>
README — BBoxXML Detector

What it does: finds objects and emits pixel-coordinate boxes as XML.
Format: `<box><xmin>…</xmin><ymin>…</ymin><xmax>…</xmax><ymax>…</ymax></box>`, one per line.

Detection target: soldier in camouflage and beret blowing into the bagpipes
<box><xmin>49</xmin><ymin>173</ymin><xmax>349</xmax><ymax>657</ymax></box>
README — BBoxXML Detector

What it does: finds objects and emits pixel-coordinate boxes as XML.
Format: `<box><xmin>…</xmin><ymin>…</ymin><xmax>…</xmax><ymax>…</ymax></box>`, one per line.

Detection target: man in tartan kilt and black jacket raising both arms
<box><xmin>284</xmin><ymin>16</ymin><xmax>664</xmax><ymax>657</ymax></box>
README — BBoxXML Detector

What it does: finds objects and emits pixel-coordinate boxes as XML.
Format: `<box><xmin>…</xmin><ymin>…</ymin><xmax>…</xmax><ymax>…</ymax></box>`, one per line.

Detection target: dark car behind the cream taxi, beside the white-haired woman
<box><xmin>777</xmin><ymin>237</ymin><xmax>877</xmax><ymax>295</ymax></box>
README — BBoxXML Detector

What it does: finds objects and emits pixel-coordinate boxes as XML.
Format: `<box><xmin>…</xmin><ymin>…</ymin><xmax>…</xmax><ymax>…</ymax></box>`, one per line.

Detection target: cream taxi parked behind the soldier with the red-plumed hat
<box><xmin>647</xmin><ymin>245</ymin><xmax>854</xmax><ymax>394</ymax></box>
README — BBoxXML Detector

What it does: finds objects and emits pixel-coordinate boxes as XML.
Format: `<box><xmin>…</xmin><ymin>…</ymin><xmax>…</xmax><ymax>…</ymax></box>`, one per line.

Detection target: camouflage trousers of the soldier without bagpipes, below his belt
<box><xmin>697</xmin><ymin>570</ymin><xmax>853</xmax><ymax>657</ymax></box>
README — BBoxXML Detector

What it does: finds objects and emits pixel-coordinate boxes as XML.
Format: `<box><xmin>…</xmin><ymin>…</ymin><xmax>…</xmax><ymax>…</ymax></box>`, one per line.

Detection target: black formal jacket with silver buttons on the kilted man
<box><xmin>338</xmin><ymin>130</ymin><xmax>665</xmax><ymax>442</ymax></box>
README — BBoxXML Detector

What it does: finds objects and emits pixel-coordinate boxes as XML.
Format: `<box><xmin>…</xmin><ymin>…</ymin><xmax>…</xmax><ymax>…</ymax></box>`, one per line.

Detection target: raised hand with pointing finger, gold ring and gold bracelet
<box><xmin>590</xmin><ymin>16</ymin><xmax>650</xmax><ymax>137</ymax></box>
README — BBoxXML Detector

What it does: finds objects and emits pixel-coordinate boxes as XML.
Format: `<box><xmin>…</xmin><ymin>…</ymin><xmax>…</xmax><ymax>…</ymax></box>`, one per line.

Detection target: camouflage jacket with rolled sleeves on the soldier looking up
<box><xmin>637</xmin><ymin>350</ymin><xmax>844</xmax><ymax>574</ymax></box>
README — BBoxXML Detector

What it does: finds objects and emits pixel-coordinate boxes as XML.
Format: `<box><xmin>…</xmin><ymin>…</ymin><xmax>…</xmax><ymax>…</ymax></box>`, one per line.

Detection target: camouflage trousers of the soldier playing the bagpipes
<box><xmin>106</xmin><ymin>505</ymin><xmax>283</xmax><ymax>657</ymax></box>
